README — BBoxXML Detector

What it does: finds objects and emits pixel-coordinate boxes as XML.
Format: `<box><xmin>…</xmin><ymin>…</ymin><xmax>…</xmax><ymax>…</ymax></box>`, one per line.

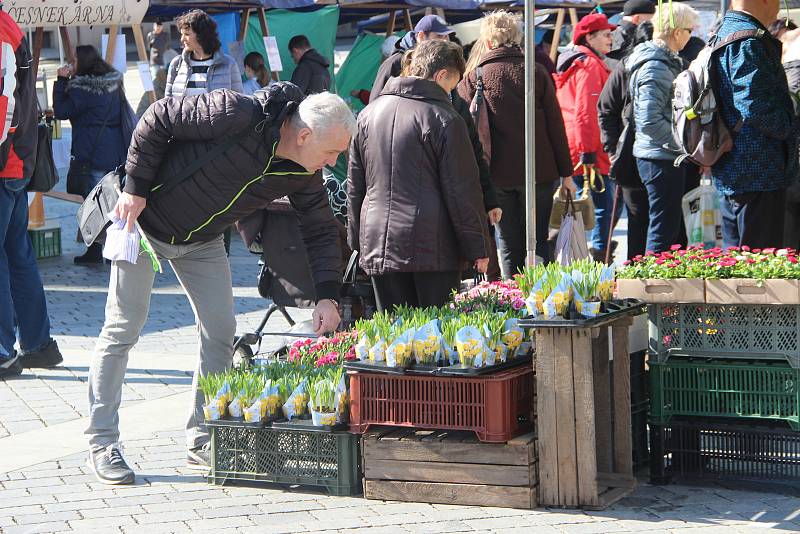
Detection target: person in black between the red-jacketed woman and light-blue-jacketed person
<box><xmin>597</xmin><ymin>21</ymin><xmax>653</xmax><ymax>260</ymax></box>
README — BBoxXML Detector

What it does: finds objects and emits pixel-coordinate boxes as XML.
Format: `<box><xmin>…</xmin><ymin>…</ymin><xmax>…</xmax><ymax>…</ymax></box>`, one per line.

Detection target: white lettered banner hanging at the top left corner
<box><xmin>3</xmin><ymin>0</ymin><xmax>150</xmax><ymax>28</ymax></box>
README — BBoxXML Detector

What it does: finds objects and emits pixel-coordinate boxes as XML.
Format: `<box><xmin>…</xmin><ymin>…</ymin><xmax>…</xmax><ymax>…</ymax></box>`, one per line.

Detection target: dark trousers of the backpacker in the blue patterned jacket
<box><xmin>719</xmin><ymin>189</ymin><xmax>786</xmax><ymax>248</ymax></box>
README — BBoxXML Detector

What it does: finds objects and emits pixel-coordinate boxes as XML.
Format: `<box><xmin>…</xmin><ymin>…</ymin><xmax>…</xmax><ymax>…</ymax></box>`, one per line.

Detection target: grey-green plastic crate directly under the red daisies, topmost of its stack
<box><xmin>647</xmin><ymin>304</ymin><xmax>800</xmax><ymax>368</ymax></box>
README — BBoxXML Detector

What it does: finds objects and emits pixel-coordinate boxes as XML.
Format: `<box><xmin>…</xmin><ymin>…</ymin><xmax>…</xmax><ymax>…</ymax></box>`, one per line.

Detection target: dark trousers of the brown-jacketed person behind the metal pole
<box><xmin>495</xmin><ymin>182</ymin><xmax>556</xmax><ymax>278</ymax></box>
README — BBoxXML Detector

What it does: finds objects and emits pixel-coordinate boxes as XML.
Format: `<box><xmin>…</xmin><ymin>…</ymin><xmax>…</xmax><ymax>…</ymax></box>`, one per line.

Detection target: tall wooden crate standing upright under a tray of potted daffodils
<box><xmin>535</xmin><ymin>317</ymin><xmax>636</xmax><ymax>509</ymax></box>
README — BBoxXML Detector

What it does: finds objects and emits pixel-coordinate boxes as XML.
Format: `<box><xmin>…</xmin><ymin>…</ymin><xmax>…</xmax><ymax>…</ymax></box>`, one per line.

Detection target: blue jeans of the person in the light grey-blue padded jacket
<box><xmin>636</xmin><ymin>158</ymin><xmax>686</xmax><ymax>253</ymax></box>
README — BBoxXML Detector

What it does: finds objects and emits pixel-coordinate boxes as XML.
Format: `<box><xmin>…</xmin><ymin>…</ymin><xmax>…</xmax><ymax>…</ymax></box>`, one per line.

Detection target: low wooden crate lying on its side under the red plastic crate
<box><xmin>361</xmin><ymin>427</ymin><xmax>537</xmax><ymax>509</ymax></box>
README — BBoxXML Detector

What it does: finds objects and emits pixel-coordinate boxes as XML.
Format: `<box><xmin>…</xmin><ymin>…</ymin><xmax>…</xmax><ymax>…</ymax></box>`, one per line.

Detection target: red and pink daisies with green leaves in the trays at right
<box><xmin>617</xmin><ymin>245</ymin><xmax>800</xmax><ymax>280</ymax></box>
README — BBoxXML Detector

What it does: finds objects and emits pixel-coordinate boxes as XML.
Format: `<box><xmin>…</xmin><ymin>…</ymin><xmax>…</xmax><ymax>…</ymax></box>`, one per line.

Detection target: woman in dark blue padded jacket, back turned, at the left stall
<box><xmin>53</xmin><ymin>46</ymin><xmax>133</xmax><ymax>264</ymax></box>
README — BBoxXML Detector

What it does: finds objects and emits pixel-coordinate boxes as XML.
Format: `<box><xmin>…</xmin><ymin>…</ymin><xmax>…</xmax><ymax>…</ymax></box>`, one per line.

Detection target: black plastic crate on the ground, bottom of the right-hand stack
<box><xmin>650</xmin><ymin>417</ymin><xmax>800</xmax><ymax>484</ymax></box>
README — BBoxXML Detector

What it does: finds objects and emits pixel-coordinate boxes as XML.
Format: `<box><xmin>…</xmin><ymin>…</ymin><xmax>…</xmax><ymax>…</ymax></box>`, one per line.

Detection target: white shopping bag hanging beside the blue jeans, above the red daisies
<box><xmin>681</xmin><ymin>177</ymin><xmax>722</xmax><ymax>248</ymax></box>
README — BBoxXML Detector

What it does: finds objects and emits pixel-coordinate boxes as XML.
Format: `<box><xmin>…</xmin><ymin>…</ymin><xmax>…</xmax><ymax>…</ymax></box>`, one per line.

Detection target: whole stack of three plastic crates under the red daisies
<box><xmin>648</xmin><ymin>304</ymin><xmax>800</xmax><ymax>483</ymax></box>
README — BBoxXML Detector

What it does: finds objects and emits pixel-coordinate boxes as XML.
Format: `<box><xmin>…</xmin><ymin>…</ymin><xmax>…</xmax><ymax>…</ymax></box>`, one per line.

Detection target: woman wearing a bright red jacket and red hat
<box><xmin>553</xmin><ymin>13</ymin><xmax>616</xmax><ymax>260</ymax></box>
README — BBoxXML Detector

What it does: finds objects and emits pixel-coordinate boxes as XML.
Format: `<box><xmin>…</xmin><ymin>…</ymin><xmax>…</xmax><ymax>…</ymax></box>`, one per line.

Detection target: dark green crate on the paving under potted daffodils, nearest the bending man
<box><xmin>206</xmin><ymin>421</ymin><xmax>362</xmax><ymax>496</ymax></box>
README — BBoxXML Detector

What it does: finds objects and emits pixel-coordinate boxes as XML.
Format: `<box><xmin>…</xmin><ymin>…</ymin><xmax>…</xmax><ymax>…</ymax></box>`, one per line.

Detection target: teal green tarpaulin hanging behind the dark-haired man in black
<box><xmin>244</xmin><ymin>6</ymin><xmax>339</xmax><ymax>87</ymax></box>
